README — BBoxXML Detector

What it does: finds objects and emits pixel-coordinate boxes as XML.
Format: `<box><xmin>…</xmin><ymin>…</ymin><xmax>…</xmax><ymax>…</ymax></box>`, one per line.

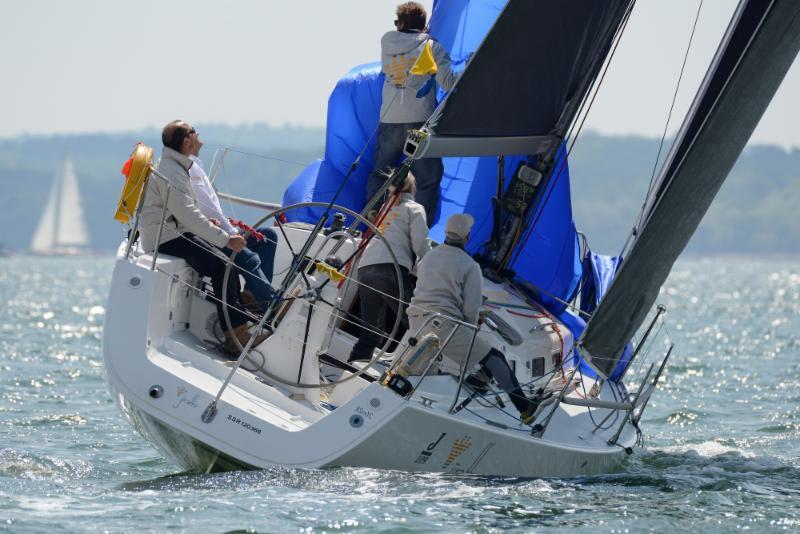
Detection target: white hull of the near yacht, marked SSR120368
<box><xmin>103</xmin><ymin>241</ymin><xmax>637</xmax><ymax>477</ymax></box>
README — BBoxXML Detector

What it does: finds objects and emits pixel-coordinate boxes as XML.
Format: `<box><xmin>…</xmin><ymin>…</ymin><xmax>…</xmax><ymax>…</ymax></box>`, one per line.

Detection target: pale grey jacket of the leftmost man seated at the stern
<box><xmin>139</xmin><ymin>147</ymin><xmax>230</xmax><ymax>252</ymax></box>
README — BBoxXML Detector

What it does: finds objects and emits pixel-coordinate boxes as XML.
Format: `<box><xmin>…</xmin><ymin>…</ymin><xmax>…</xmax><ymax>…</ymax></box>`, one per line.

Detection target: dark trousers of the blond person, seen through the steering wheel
<box><xmin>348</xmin><ymin>263</ymin><xmax>411</xmax><ymax>361</ymax></box>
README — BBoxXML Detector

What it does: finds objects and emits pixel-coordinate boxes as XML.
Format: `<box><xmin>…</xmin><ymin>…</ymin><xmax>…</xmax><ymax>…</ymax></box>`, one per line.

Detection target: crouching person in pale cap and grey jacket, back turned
<box><xmin>407</xmin><ymin>213</ymin><xmax>539</xmax><ymax>423</ymax></box>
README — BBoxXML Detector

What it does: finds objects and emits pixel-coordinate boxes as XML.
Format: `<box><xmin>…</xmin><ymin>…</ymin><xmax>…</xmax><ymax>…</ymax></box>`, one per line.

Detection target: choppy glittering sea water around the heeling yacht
<box><xmin>0</xmin><ymin>256</ymin><xmax>800</xmax><ymax>532</ymax></box>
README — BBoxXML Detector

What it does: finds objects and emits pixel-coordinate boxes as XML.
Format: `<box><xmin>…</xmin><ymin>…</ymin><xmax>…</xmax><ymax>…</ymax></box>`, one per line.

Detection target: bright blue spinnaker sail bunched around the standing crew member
<box><xmin>283</xmin><ymin>0</ymin><xmax>581</xmax><ymax>313</ymax></box>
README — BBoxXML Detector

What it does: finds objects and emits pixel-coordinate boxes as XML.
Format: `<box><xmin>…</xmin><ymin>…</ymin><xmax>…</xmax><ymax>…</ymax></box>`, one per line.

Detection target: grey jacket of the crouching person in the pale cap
<box><xmin>408</xmin><ymin>244</ymin><xmax>483</xmax><ymax>324</ymax></box>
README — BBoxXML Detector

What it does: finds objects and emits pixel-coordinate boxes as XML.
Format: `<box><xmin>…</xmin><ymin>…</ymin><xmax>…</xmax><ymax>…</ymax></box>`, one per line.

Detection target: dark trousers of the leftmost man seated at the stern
<box><xmin>158</xmin><ymin>233</ymin><xmax>247</xmax><ymax>330</ymax></box>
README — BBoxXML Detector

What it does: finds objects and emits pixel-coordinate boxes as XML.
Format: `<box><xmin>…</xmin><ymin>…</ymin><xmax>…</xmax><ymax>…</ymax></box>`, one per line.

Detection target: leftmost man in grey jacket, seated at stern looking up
<box><xmin>139</xmin><ymin>120</ymin><xmax>266</xmax><ymax>355</ymax></box>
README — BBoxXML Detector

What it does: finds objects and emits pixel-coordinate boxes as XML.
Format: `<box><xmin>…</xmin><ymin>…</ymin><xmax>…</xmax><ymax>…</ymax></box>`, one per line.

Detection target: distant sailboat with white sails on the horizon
<box><xmin>30</xmin><ymin>157</ymin><xmax>89</xmax><ymax>256</ymax></box>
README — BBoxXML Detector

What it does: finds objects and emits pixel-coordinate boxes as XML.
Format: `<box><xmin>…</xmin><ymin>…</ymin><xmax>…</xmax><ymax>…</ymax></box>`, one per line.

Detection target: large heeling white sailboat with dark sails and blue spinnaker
<box><xmin>103</xmin><ymin>0</ymin><xmax>800</xmax><ymax>477</ymax></box>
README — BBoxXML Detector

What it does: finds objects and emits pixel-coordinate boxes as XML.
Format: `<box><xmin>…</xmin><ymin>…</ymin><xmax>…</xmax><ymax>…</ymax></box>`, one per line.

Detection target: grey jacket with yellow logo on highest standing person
<box><xmin>380</xmin><ymin>31</ymin><xmax>458</xmax><ymax>123</ymax></box>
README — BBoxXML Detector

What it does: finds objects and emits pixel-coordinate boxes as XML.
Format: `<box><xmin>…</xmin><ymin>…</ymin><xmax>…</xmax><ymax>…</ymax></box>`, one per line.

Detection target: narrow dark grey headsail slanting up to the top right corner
<box><xmin>579</xmin><ymin>0</ymin><xmax>800</xmax><ymax>376</ymax></box>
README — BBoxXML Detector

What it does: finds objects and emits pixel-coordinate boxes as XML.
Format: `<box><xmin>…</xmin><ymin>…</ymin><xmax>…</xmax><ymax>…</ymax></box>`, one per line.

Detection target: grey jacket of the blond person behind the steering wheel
<box><xmin>359</xmin><ymin>193</ymin><xmax>431</xmax><ymax>271</ymax></box>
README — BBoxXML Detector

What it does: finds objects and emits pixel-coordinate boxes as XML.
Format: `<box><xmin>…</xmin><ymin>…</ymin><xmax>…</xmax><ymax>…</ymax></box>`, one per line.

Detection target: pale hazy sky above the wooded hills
<box><xmin>0</xmin><ymin>0</ymin><xmax>800</xmax><ymax>148</ymax></box>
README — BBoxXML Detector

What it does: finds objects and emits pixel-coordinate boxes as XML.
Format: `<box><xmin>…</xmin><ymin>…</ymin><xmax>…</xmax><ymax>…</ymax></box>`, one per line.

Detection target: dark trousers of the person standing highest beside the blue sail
<box><xmin>367</xmin><ymin>122</ymin><xmax>444</xmax><ymax>228</ymax></box>
